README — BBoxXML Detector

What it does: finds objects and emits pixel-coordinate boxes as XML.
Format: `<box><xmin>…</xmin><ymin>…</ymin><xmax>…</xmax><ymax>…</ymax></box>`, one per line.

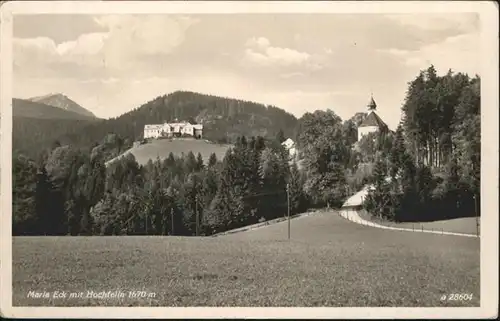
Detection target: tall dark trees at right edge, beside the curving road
<box><xmin>365</xmin><ymin>66</ymin><xmax>481</xmax><ymax>221</ymax></box>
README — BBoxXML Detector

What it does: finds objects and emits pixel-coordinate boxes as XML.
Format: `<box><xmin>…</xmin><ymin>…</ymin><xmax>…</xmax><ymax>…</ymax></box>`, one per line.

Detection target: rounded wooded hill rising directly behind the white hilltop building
<box><xmin>42</xmin><ymin>91</ymin><xmax>297</xmax><ymax>153</ymax></box>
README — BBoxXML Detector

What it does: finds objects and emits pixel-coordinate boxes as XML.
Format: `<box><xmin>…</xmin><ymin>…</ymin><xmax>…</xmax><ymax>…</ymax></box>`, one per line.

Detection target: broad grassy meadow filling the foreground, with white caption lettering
<box><xmin>13</xmin><ymin>212</ymin><xmax>480</xmax><ymax>307</ymax></box>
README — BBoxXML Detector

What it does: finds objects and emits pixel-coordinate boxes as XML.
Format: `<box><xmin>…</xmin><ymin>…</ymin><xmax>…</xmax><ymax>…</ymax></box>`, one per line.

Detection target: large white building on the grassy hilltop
<box><xmin>144</xmin><ymin>121</ymin><xmax>203</xmax><ymax>138</ymax></box>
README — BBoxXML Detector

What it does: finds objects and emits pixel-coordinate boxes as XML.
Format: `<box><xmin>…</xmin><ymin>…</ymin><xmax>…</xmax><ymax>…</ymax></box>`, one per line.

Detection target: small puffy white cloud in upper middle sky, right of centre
<box><xmin>245</xmin><ymin>37</ymin><xmax>311</xmax><ymax>66</ymax></box>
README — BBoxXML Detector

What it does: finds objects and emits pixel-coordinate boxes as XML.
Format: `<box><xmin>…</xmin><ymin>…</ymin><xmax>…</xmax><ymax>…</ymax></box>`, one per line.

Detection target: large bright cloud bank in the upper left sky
<box><xmin>14</xmin><ymin>15</ymin><xmax>198</xmax><ymax>77</ymax></box>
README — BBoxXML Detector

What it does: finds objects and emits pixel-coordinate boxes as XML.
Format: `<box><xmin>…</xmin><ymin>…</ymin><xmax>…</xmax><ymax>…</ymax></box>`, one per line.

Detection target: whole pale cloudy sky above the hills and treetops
<box><xmin>13</xmin><ymin>13</ymin><xmax>480</xmax><ymax>129</ymax></box>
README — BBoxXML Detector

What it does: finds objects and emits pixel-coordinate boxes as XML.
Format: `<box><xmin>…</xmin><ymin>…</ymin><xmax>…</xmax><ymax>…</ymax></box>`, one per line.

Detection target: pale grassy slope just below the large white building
<box><xmin>106</xmin><ymin>139</ymin><xmax>231</xmax><ymax>166</ymax></box>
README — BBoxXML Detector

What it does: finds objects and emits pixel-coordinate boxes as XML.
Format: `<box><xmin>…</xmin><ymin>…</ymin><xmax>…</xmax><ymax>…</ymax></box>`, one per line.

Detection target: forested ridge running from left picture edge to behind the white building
<box><xmin>13</xmin><ymin>91</ymin><xmax>297</xmax><ymax>157</ymax></box>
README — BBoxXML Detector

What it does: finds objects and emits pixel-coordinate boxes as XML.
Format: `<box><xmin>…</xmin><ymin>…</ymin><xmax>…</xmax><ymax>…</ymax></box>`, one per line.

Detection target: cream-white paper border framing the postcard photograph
<box><xmin>0</xmin><ymin>1</ymin><xmax>499</xmax><ymax>319</ymax></box>
